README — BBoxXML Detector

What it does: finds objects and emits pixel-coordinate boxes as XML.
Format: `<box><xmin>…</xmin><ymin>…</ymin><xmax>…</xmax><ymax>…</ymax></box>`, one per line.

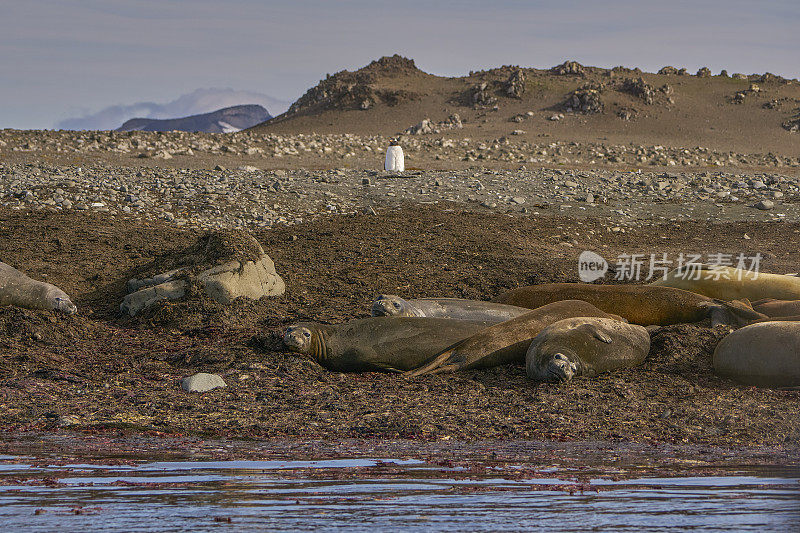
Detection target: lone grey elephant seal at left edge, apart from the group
<box><xmin>0</xmin><ymin>262</ymin><xmax>78</xmax><ymax>315</ymax></box>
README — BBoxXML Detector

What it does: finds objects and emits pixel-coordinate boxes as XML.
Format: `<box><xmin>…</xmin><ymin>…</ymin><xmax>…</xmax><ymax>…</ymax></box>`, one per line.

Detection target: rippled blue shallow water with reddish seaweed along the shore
<box><xmin>0</xmin><ymin>456</ymin><xmax>800</xmax><ymax>531</ymax></box>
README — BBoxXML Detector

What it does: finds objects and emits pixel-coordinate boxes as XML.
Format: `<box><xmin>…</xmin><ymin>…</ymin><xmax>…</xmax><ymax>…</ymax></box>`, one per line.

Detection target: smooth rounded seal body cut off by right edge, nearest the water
<box><xmin>713</xmin><ymin>321</ymin><xmax>800</xmax><ymax>387</ymax></box>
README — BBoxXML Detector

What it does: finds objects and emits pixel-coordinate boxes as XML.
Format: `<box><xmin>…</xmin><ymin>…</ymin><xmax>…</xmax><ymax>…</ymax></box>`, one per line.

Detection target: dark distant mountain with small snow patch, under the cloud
<box><xmin>117</xmin><ymin>105</ymin><xmax>272</xmax><ymax>133</ymax></box>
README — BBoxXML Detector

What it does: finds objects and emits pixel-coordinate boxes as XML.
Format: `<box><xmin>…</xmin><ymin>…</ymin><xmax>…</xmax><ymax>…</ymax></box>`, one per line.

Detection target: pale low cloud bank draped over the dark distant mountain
<box><xmin>56</xmin><ymin>89</ymin><xmax>290</xmax><ymax>130</ymax></box>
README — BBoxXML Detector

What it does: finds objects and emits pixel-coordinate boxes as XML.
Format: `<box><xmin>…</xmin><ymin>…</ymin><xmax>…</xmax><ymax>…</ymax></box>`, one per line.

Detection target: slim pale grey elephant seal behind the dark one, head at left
<box><xmin>372</xmin><ymin>294</ymin><xmax>530</xmax><ymax>324</ymax></box>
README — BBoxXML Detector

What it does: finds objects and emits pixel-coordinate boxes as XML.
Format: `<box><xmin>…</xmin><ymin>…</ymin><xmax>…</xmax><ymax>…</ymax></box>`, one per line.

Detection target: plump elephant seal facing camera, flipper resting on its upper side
<box><xmin>525</xmin><ymin>318</ymin><xmax>650</xmax><ymax>382</ymax></box>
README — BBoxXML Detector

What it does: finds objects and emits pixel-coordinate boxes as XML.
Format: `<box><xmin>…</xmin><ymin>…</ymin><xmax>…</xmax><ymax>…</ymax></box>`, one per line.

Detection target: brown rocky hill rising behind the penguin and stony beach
<box><xmin>254</xmin><ymin>55</ymin><xmax>800</xmax><ymax>155</ymax></box>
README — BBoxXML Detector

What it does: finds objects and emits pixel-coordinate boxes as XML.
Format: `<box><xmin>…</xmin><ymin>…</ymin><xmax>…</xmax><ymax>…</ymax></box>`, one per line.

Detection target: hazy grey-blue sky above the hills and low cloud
<box><xmin>0</xmin><ymin>0</ymin><xmax>800</xmax><ymax>128</ymax></box>
